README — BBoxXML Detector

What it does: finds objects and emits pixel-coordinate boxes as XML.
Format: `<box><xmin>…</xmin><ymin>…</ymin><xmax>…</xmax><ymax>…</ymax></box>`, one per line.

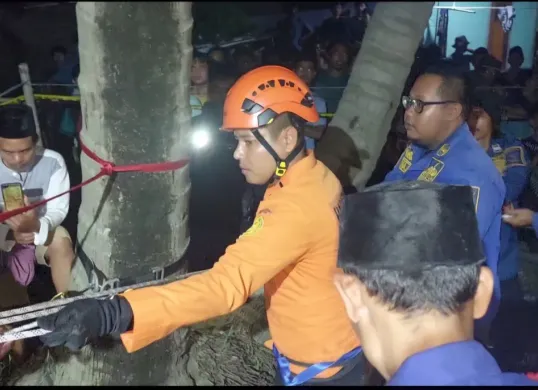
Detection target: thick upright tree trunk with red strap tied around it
<box><xmin>13</xmin><ymin>2</ymin><xmax>192</xmax><ymax>386</ymax></box>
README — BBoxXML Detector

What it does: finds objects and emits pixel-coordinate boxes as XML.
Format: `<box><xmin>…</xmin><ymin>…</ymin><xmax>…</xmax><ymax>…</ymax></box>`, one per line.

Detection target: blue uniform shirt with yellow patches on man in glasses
<box><xmin>385</xmin><ymin>123</ymin><xmax>506</xmax><ymax>323</ymax></box>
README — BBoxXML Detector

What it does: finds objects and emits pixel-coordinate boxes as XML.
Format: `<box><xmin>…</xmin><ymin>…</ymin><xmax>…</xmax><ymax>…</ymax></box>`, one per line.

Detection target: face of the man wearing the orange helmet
<box><xmin>230</xmin><ymin>126</ymin><xmax>298</xmax><ymax>184</ymax></box>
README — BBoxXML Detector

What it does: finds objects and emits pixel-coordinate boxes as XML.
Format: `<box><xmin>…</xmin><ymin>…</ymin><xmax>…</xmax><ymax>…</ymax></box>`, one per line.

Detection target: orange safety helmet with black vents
<box><xmin>221</xmin><ymin>65</ymin><xmax>319</xmax><ymax>131</ymax></box>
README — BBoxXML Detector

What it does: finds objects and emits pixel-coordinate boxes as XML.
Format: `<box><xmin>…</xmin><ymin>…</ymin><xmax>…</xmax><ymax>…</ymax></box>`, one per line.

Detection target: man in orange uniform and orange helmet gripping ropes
<box><xmin>38</xmin><ymin>66</ymin><xmax>363</xmax><ymax>385</ymax></box>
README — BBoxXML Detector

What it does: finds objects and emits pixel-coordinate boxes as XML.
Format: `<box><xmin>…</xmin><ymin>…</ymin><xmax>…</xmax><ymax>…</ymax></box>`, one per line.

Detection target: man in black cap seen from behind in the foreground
<box><xmin>334</xmin><ymin>182</ymin><xmax>538</xmax><ymax>386</ymax></box>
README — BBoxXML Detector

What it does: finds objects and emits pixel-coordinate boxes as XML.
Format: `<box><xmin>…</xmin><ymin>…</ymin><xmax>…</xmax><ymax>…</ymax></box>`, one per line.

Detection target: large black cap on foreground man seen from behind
<box><xmin>338</xmin><ymin>182</ymin><xmax>485</xmax><ymax>271</ymax></box>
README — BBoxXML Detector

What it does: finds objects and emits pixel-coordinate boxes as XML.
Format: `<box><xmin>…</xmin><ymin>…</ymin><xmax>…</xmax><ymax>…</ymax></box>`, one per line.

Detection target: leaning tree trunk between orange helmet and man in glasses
<box><xmin>316</xmin><ymin>2</ymin><xmax>434</xmax><ymax>190</ymax></box>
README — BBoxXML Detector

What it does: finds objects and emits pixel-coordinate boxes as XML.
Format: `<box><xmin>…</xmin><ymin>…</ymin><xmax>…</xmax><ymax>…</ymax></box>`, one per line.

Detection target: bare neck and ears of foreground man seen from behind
<box><xmin>334</xmin><ymin>267</ymin><xmax>493</xmax><ymax>379</ymax></box>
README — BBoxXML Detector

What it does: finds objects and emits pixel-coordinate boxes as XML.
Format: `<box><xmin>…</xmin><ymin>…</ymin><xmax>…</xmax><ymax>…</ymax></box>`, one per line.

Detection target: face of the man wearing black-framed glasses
<box><xmin>404</xmin><ymin>74</ymin><xmax>462</xmax><ymax>146</ymax></box>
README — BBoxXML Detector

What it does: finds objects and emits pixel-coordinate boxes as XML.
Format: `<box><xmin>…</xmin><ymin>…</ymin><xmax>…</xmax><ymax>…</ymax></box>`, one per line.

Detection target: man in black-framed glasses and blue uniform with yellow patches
<box><xmin>385</xmin><ymin>69</ymin><xmax>506</xmax><ymax>339</ymax></box>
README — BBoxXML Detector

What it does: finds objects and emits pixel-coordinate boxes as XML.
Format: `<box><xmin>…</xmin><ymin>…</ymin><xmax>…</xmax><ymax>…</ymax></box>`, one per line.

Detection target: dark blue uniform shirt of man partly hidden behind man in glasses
<box><xmin>488</xmin><ymin>136</ymin><xmax>530</xmax><ymax>280</ymax></box>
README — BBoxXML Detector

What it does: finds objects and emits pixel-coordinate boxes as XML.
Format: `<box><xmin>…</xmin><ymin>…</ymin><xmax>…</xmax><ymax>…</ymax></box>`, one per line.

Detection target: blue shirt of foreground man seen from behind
<box><xmin>387</xmin><ymin>341</ymin><xmax>538</xmax><ymax>386</ymax></box>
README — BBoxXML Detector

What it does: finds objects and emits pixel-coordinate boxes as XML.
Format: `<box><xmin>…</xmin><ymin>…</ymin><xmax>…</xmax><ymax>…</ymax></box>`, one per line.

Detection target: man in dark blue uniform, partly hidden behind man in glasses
<box><xmin>469</xmin><ymin>91</ymin><xmax>530</xmax><ymax>301</ymax></box>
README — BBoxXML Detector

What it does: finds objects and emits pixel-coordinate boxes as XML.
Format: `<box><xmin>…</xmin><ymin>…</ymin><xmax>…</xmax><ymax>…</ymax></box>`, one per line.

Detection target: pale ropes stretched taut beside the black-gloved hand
<box><xmin>0</xmin><ymin>271</ymin><xmax>204</xmax><ymax>343</ymax></box>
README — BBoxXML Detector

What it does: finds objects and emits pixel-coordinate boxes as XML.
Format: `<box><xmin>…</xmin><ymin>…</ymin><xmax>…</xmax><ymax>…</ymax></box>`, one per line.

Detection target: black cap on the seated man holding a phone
<box><xmin>0</xmin><ymin>104</ymin><xmax>37</xmax><ymax>139</ymax></box>
